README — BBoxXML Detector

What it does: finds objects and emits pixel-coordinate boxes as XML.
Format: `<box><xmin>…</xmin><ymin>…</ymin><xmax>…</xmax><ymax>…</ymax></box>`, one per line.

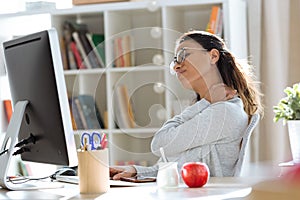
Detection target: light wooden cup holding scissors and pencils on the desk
<box><xmin>77</xmin><ymin>148</ymin><xmax>109</xmax><ymax>194</ymax></box>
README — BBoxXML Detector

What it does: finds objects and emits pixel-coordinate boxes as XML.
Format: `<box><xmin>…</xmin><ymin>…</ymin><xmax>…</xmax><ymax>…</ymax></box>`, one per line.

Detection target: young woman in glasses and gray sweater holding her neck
<box><xmin>110</xmin><ymin>31</ymin><xmax>262</xmax><ymax>179</ymax></box>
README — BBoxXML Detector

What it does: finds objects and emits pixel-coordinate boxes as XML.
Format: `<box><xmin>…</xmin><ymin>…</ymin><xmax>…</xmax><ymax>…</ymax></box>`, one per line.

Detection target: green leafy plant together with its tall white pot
<box><xmin>273</xmin><ymin>83</ymin><xmax>300</xmax><ymax>163</ymax></box>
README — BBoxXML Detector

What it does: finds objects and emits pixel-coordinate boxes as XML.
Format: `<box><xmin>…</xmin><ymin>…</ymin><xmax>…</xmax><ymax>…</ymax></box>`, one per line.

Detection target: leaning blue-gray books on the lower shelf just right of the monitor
<box><xmin>69</xmin><ymin>95</ymin><xmax>106</xmax><ymax>130</ymax></box>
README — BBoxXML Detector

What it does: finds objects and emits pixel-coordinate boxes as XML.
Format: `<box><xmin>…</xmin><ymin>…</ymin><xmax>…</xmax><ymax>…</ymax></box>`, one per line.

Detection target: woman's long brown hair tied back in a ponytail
<box><xmin>179</xmin><ymin>31</ymin><xmax>263</xmax><ymax>116</ymax></box>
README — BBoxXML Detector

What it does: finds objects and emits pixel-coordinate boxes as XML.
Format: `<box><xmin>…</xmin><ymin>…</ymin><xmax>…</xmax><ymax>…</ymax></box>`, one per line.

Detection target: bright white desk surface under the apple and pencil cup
<box><xmin>0</xmin><ymin>177</ymin><xmax>262</xmax><ymax>200</ymax></box>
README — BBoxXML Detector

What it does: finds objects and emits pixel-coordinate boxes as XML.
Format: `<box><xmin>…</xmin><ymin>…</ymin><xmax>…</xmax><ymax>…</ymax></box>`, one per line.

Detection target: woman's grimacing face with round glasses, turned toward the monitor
<box><xmin>174</xmin><ymin>40</ymin><xmax>211</xmax><ymax>90</ymax></box>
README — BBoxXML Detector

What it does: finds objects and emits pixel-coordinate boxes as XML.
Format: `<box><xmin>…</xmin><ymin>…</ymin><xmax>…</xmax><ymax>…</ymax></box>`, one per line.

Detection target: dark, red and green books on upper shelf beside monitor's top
<box><xmin>62</xmin><ymin>21</ymin><xmax>105</xmax><ymax>69</ymax></box>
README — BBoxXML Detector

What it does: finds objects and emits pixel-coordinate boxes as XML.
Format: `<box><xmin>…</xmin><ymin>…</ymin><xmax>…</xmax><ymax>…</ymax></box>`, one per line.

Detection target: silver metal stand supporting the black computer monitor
<box><xmin>0</xmin><ymin>100</ymin><xmax>63</xmax><ymax>190</ymax></box>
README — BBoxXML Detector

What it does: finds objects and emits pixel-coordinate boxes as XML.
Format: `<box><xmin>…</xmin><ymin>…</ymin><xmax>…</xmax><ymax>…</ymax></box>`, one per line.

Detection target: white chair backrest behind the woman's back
<box><xmin>234</xmin><ymin>113</ymin><xmax>260</xmax><ymax>176</ymax></box>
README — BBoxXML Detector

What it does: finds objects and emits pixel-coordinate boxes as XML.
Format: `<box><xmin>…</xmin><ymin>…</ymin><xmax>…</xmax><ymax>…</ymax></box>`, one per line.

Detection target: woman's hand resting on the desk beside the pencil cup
<box><xmin>109</xmin><ymin>166</ymin><xmax>137</xmax><ymax>180</ymax></box>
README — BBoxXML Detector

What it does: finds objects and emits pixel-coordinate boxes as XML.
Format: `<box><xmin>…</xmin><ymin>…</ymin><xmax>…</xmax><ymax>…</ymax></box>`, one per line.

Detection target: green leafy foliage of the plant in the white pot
<box><xmin>273</xmin><ymin>83</ymin><xmax>300</xmax><ymax>124</ymax></box>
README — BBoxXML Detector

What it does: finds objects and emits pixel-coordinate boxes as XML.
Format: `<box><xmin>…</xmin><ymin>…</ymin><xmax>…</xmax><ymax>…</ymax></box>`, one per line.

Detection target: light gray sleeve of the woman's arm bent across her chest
<box><xmin>151</xmin><ymin>99</ymin><xmax>240</xmax><ymax>157</ymax></box>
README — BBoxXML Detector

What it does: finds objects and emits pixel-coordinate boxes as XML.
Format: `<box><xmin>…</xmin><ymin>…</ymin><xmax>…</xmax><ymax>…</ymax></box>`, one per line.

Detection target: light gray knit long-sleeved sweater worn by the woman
<box><xmin>134</xmin><ymin>97</ymin><xmax>248</xmax><ymax>177</ymax></box>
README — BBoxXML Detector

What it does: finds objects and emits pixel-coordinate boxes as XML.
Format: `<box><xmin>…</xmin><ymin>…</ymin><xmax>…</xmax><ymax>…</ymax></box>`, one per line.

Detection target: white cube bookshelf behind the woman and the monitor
<box><xmin>0</xmin><ymin>0</ymin><xmax>248</xmax><ymax>165</ymax></box>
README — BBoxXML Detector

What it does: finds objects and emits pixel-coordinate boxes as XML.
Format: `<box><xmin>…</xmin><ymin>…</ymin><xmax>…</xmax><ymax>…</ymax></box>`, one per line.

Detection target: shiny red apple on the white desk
<box><xmin>181</xmin><ymin>162</ymin><xmax>209</xmax><ymax>188</ymax></box>
